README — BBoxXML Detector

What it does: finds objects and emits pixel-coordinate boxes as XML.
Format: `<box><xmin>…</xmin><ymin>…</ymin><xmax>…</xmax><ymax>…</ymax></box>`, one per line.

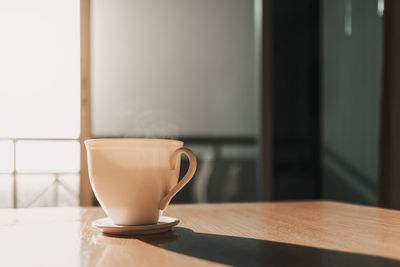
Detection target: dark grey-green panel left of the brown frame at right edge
<box><xmin>322</xmin><ymin>0</ymin><xmax>383</xmax><ymax>204</ymax></box>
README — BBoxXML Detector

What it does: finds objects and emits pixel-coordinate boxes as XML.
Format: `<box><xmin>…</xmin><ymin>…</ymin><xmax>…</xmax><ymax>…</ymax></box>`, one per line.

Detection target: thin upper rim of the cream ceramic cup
<box><xmin>84</xmin><ymin>137</ymin><xmax>183</xmax><ymax>146</ymax></box>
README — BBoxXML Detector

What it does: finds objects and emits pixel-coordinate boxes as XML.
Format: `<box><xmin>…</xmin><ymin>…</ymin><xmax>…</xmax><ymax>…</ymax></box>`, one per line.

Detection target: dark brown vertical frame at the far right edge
<box><xmin>379</xmin><ymin>0</ymin><xmax>400</xmax><ymax>209</ymax></box>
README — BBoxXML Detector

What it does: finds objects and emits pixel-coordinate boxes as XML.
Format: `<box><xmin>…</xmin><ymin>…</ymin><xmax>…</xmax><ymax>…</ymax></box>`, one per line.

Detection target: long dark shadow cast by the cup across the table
<box><xmin>137</xmin><ymin>227</ymin><xmax>400</xmax><ymax>267</ymax></box>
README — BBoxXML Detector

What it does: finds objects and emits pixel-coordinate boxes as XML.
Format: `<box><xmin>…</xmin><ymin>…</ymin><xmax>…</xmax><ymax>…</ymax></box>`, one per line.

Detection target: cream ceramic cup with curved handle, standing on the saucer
<box><xmin>85</xmin><ymin>138</ymin><xmax>197</xmax><ymax>225</ymax></box>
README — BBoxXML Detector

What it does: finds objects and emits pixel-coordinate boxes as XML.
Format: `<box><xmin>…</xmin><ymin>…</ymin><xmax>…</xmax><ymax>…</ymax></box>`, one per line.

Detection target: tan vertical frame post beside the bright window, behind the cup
<box><xmin>79</xmin><ymin>0</ymin><xmax>94</xmax><ymax>206</ymax></box>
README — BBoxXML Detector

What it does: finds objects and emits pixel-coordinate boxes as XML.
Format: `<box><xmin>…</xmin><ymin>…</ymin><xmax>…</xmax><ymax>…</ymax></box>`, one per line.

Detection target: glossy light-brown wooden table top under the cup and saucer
<box><xmin>0</xmin><ymin>201</ymin><xmax>400</xmax><ymax>267</ymax></box>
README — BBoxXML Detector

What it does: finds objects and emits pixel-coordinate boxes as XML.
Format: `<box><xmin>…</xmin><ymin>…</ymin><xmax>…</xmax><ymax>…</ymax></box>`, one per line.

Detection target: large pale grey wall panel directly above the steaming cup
<box><xmin>91</xmin><ymin>0</ymin><xmax>260</xmax><ymax>137</ymax></box>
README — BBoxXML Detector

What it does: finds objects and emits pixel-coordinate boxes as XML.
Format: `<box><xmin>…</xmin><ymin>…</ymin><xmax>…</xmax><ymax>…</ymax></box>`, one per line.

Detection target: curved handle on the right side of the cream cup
<box><xmin>159</xmin><ymin>147</ymin><xmax>197</xmax><ymax>210</ymax></box>
